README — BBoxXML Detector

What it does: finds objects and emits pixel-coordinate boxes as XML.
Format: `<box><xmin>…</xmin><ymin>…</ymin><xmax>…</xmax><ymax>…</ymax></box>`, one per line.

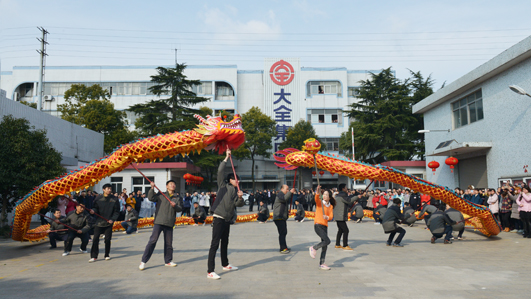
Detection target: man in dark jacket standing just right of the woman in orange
<box><xmin>334</xmin><ymin>184</ymin><xmax>354</xmax><ymax>250</ymax></box>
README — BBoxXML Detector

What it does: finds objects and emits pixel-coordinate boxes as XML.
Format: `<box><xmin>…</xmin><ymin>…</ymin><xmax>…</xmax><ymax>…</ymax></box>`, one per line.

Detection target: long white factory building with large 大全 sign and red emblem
<box><xmin>0</xmin><ymin>58</ymin><xmax>396</xmax><ymax>190</ymax></box>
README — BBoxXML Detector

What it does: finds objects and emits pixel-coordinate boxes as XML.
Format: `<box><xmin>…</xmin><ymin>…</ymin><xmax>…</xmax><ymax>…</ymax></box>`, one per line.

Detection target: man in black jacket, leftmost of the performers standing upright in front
<box><xmin>89</xmin><ymin>184</ymin><xmax>120</xmax><ymax>262</ymax></box>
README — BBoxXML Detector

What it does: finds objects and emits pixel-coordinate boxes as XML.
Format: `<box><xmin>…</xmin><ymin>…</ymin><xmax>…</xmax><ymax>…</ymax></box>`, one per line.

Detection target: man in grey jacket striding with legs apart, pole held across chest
<box><xmin>138</xmin><ymin>180</ymin><xmax>183</xmax><ymax>270</ymax></box>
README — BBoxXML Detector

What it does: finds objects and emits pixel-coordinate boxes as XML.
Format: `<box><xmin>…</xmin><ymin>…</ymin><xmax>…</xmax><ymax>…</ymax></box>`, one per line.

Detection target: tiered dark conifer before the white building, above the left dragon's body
<box><xmin>128</xmin><ymin>63</ymin><xmax>208</xmax><ymax>136</ymax></box>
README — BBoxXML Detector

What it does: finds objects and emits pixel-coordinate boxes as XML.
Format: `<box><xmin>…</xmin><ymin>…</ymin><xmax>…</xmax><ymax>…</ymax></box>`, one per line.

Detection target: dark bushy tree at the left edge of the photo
<box><xmin>0</xmin><ymin>115</ymin><xmax>65</xmax><ymax>226</ymax></box>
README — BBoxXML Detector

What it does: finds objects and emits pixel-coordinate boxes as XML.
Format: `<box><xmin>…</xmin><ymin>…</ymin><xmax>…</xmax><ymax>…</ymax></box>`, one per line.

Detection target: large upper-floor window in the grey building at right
<box><xmin>452</xmin><ymin>89</ymin><xmax>483</xmax><ymax>129</ymax></box>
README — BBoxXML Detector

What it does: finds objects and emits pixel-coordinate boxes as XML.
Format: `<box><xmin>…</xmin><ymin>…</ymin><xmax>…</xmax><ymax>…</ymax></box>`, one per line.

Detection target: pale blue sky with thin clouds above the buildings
<box><xmin>0</xmin><ymin>0</ymin><xmax>531</xmax><ymax>90</ymax></box>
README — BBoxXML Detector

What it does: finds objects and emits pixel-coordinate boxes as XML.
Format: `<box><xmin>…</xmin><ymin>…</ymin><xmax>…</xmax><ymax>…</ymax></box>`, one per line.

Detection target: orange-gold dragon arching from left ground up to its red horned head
<box><xmin>12</xmin><ymin>114</ymin><xmax>245</xmax><ymax>241</ymax></box>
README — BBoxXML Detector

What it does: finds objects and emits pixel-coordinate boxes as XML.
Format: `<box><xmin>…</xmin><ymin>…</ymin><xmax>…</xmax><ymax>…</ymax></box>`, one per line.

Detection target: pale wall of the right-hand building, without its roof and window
<box><xmin>424</xmin><ymin>59</ymin><xmax>531</xmax><ymax>188</ymax></box>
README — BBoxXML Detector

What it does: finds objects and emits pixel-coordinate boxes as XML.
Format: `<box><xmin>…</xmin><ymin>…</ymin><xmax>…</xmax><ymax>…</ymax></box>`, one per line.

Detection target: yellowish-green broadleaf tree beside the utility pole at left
<box><xmin>57</xmin><ymin>84</ymin><xmax>136</xmax><ymax>153</ymax></box>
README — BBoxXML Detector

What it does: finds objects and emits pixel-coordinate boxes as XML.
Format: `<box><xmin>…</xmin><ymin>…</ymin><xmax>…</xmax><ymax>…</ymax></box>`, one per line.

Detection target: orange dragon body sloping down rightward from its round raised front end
<box><xmin>275</xmin><ymin>142</ymin><xmax>501</xmax><ymax>237</ymax></box>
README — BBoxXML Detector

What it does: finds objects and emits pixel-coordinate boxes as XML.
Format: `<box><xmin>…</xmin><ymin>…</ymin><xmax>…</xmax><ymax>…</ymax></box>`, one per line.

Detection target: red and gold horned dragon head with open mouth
<box><xmin>194</xmin><ymin>114</ymin><xmax>245</xmax><ymax>154</ymax></box>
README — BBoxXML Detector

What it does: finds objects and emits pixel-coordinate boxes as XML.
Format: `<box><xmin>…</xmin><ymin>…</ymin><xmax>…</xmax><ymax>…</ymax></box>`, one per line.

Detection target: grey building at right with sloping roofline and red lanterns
<box><xmin>413</xmin><ymin>37</ymin><xmax>531</xmax><ymax>188</ymax></box>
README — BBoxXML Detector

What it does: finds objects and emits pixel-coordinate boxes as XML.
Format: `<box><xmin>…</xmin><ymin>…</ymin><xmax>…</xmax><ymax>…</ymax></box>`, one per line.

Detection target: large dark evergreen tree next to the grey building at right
<box><xmin>340</xmin><ymin>68</ymin><xmax>433</xmax><ymax>164</ymax></box>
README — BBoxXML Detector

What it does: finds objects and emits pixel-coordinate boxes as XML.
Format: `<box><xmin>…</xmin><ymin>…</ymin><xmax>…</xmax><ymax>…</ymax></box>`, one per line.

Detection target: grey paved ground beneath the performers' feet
<box><xmin>0</xmin><ymin>207</ymin><xmax>531</xmax><ymax>298</ymax></box>
